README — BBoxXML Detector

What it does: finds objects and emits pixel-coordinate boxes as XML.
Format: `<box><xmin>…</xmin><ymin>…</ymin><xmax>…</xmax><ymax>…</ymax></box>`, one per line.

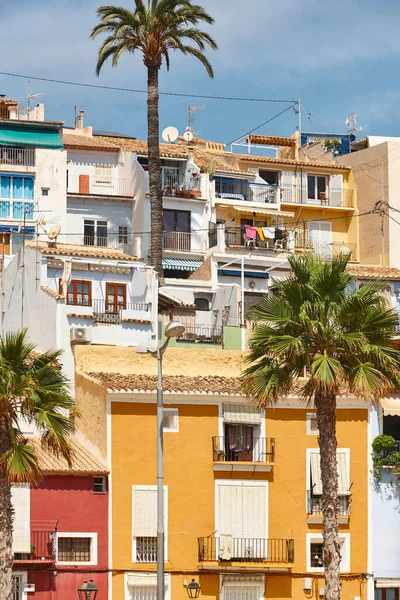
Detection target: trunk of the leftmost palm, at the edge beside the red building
<box><xmin>0</xmin><ymin>423</ymin><xmax>14</xmax><ymax>600</ymax></box>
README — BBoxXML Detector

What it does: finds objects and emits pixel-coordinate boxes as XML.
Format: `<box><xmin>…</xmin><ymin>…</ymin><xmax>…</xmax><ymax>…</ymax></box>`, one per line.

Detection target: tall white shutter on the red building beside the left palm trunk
<box><xmin>11</xmin><ymin>483</ymin><xmax>31</xmax><ymax>554</ymax></box>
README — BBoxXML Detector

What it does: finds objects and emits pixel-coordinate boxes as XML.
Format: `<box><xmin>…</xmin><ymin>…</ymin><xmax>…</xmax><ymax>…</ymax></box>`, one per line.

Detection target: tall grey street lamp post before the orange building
<box><xmin>136</xmin><ymin>321</ymin><xmax>185</xmax><ymax>600</ymax></box>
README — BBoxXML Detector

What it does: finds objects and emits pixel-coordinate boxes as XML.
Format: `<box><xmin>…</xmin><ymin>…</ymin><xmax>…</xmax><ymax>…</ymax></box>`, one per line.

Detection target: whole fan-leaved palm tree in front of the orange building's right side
<box><xmin>243</xmin><ymin>256</ymin><xmax>400</xmax><ymax>600</ymax></box>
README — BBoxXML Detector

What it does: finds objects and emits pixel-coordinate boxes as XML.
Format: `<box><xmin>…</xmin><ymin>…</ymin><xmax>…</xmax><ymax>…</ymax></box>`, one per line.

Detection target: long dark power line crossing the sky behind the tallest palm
<box><xmin>0</xmin><ymin>71</ymin><xmax>297</xmax><ymax>104</ymax></box>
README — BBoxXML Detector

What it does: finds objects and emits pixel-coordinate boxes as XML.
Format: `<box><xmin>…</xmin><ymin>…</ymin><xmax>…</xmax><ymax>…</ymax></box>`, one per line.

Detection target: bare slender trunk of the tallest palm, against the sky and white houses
<box><xmin>147</xmin><ymin>66</ymin><xmax>163</xmax><ymax>281</ymax></box>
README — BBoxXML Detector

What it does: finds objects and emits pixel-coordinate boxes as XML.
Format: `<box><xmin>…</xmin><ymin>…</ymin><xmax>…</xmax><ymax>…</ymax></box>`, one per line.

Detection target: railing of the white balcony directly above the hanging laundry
<box><xmin>215</xmin><ymin>177</ymin><xmax>280</xmax><ymax>204</ymax></box>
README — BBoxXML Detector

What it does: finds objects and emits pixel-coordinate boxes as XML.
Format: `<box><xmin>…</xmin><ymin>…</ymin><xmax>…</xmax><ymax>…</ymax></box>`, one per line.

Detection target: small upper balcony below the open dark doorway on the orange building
<box><xmin>212</xmin><ymin>436</ymin><xmax>275</xmax><ymax>472</ymax></box>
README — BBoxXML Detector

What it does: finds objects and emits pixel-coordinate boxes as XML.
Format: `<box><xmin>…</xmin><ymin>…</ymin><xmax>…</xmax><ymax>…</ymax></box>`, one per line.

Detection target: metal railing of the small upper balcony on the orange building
<box><xmin>212</xmin><ymin>436</ymin><xmax>275</xmax><ymax>463</ymax></box>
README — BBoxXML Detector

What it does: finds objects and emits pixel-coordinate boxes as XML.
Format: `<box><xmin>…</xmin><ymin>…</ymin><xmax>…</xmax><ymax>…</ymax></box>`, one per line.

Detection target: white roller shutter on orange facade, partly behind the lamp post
<box><xmin>132</xmin><ymin>486</ymin><xmax>167</xmax><ymax>537</ymax></box>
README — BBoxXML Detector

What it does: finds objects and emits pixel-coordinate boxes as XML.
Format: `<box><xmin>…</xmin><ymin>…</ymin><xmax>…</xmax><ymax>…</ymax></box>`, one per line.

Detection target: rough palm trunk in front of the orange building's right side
<box><xmin>315</xmin><ymin>393</ymin><xmax>341</xmax><ymax>600</ymax></box>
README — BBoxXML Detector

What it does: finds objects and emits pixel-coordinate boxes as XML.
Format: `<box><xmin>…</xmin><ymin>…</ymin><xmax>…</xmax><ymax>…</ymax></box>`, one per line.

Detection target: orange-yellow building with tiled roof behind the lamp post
<box><xmin>77</xmin><ymin>348</ymin><xmax>368</xmax><ymax>600</ymax></box>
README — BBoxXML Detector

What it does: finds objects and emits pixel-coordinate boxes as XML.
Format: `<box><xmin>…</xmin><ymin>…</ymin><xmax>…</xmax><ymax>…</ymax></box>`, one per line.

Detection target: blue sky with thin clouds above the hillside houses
<box><xmin>0</xmin><ymin>0</ymin><xmax>400</xmax><ymax>142</ymax></box>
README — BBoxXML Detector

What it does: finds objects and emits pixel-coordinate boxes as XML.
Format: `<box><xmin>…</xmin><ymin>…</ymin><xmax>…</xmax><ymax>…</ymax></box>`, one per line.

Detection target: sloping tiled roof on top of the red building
<box><xmin>27</xmin><ymin>436</ymin><xmax>108</xmax><ymax>475</ymax></box>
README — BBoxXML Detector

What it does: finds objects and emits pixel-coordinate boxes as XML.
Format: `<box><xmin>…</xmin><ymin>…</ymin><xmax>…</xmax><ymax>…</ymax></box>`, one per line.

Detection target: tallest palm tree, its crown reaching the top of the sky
<box><xmin>91</xmin><ymin>0</ymin><xmax>217</xmax><ymax>276</ymax></box>
